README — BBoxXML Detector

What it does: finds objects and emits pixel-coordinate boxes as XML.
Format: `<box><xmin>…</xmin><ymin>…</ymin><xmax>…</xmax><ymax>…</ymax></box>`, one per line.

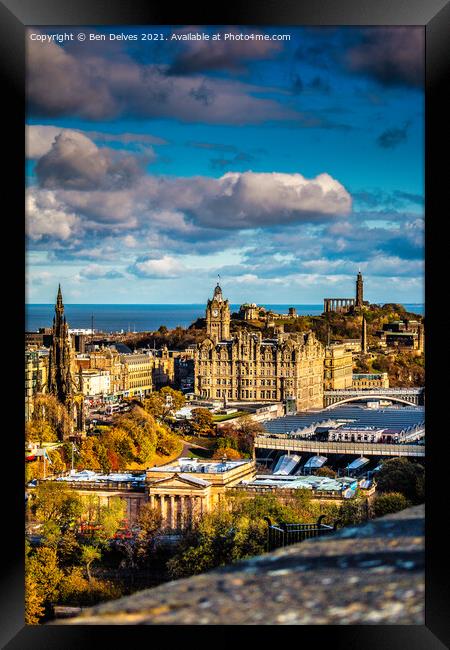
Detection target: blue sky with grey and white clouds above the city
<box><xmin>26</xmin><ymin>26</ymin><xmax>424</xmax><ymax>304</ymax></box>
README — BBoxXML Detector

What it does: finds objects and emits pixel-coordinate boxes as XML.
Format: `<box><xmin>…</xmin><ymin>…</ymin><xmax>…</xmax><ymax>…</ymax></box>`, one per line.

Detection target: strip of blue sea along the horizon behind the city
<box><xmin>26</xmin><ymin>304</ymin><xmax>425</xmax><ymax>332</ymax></box>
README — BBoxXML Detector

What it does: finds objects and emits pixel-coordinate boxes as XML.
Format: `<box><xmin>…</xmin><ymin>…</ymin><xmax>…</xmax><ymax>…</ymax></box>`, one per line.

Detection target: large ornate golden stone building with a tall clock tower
<box><xmin>195</xmin><ymin>285</ymin><xmax>325</xmax><ymax>410</ymax></box>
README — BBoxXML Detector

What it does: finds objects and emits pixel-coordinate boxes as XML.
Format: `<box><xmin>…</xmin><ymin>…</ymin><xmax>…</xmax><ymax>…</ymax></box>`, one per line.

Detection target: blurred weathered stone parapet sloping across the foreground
<box><xmin>58</xmin><ymin>506</ymin><xmax>425</xmax><ymax>625</ymax></box>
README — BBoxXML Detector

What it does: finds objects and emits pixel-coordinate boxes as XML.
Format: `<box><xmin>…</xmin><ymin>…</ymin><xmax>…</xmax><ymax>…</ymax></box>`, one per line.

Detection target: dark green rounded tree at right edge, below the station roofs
<box><xmin>377</xmin><ymin>458</ymin><xmax>425</xmax><ymax>504</ymax></box>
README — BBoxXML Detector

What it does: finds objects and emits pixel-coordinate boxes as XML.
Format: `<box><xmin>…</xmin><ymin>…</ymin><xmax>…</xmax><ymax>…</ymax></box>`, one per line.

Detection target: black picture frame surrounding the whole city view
<box><xmin>0</xmin><ymin>0</ymin><xmax>450</xmax><ymax>650</ymax></box>
